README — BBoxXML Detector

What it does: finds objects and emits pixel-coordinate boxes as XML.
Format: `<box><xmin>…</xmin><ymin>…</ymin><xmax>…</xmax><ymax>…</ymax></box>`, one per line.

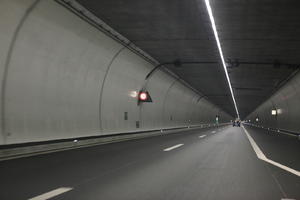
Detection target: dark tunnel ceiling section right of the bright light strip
<box><xmin>210</xmin><ymin>0</ymin><xmax>300</xmax><ymax>117</ymax></box>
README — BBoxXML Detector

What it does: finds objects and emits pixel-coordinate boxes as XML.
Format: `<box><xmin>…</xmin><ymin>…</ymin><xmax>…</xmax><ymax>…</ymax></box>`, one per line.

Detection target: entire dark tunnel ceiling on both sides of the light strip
<box><xmin>78</xmin><ymin>0</ymin><xmax>300</xmax><ymax>118</ymax></box>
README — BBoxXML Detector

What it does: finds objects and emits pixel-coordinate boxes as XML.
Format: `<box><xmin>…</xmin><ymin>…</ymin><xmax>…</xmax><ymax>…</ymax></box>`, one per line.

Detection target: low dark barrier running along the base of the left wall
<box><xmin>0</xmin><ymin>123</ymin><xmax>228</xmax><ymax>161</ymax></box>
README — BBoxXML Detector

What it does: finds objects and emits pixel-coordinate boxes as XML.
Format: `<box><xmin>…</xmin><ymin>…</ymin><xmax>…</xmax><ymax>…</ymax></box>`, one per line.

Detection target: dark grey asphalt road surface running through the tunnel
<box><xmin>0</xmin><ymin>126</ymin><xmax>300</xmax><ymax>200</ymax></box>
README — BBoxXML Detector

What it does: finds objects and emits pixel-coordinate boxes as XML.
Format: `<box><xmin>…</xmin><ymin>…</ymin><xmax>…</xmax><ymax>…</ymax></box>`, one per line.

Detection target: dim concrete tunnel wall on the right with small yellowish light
<box><xmin>246</xmin><ymin>73</ymin><xmax>300</xmax><ymax>133</ymax></box>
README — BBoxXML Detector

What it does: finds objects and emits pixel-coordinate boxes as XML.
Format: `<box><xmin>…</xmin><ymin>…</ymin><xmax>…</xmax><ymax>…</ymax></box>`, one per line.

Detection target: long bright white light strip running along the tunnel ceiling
<box><xmin>205</xmin><ymin>0</ymin><xmax>240</xmax><ymax>118</ymax></box>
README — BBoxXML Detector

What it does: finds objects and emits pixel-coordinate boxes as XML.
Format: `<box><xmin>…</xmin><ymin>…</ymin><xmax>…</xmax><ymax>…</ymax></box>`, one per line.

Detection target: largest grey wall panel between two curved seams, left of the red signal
<box><xmin>4</xmin><ymin>1</ymin><xmax>121</xmax><ymax>143</ymax></box>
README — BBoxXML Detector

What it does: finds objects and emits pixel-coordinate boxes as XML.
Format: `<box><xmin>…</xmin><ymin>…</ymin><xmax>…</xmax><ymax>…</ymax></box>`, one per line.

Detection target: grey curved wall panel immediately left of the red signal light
<box><xmin>101</xmin><ymin>49</ymin><xmax>152</xmax><ymax>133</ymax></box>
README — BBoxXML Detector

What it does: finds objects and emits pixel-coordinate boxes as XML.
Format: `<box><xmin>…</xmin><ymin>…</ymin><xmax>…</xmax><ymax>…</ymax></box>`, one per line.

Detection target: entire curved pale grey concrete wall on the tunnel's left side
<box><xmin>0</xmin><ymin>0</ymin><xmax>231</xmax><ymax>145</ymax></box>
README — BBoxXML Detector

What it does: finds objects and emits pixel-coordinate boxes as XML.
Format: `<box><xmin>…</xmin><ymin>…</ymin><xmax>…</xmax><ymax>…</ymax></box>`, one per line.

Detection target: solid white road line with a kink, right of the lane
<box><xmin>242</xmin><ymin>126</ymin><xmax>300</xmax><ymax>176</ymax></box>
